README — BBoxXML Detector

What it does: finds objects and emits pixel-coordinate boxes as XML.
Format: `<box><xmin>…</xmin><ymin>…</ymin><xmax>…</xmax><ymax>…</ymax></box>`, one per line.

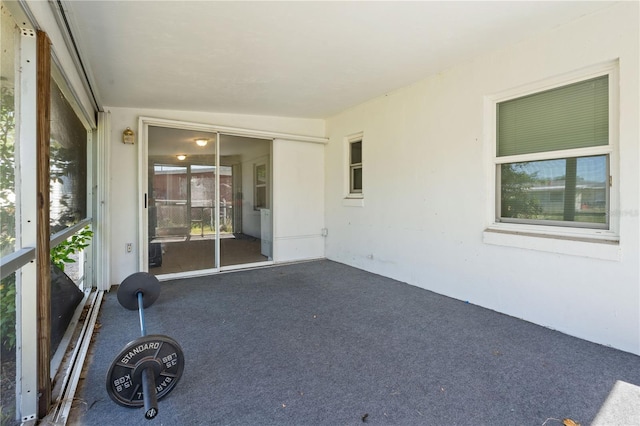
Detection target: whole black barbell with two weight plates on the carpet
<box><xmin>107</xmin><ymin>272</ymin><xmax>184</xmax><ymax>420</ymax></box>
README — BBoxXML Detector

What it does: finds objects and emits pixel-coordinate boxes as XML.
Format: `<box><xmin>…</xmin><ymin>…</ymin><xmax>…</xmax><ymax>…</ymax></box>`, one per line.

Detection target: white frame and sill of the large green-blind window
<box><xmin>483</xmin><ymin>61</ymin><xmax>620</xmax><ymax>260</ymax></box>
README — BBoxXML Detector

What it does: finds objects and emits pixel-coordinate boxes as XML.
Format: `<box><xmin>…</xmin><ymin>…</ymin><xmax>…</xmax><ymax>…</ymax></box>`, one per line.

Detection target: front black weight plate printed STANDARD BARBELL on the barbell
<box><xmin>107</xmin><ymin>335</ymin><xmax>184</xmax><ymax>408</ymax></box>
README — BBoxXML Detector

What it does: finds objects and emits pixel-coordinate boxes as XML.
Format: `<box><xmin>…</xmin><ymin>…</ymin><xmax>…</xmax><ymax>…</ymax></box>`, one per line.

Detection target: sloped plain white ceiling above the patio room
<box><xmin>64</xmin><ymin>0</ymin><xmax>612</xmax><ymax>118</ymax></box>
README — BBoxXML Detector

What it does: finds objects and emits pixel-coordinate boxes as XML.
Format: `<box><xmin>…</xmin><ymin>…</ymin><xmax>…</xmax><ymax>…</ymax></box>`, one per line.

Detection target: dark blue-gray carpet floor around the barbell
<box><xmin>74</xmin><ymin>260</ymin><xmax>640</xmax><ymax>426</ymax></box>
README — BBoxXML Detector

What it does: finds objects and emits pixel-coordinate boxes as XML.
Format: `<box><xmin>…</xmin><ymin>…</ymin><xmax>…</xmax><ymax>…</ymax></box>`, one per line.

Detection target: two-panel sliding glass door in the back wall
<box><xmin>147</xmin><ymin>126</ymin><xmax>272</xmax><ymax>275</ymax></box>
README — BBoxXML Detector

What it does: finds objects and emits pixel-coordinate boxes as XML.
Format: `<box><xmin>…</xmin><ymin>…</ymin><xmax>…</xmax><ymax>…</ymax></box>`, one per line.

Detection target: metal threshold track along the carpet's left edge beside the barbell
<box><xmin>43</xmin><ymin>290</ymin><xmax>104</xmax><ymax>425</ymax></box>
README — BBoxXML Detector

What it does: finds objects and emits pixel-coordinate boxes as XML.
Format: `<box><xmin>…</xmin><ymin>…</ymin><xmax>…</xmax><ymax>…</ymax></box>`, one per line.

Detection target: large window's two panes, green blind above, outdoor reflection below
<box><xmin>496</xmin><ymin>74</ymin><xmax>611</xmax><ymax>229</ymax></box>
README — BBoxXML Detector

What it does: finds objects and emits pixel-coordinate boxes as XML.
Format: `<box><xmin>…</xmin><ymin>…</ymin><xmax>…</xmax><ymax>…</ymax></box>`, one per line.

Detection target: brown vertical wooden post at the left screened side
<box><xmin>36</xmin><ymin>31</ymin><xmax>51</xmax><ymax>418</ymax></box>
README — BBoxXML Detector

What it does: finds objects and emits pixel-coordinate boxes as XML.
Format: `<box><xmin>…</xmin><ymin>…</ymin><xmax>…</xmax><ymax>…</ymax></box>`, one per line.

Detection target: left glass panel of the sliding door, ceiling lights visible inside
<box><xmin>147</xmin><ymin>126</ymin><xmax>217</xmax><ymax>275</ymax></box>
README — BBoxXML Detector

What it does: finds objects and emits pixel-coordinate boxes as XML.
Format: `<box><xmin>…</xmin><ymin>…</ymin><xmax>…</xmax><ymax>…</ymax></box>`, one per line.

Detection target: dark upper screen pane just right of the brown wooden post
<box><xmin>49</xmin><ymin>79</ymin><xmax>87</xmax><ymax>234</ymax></box>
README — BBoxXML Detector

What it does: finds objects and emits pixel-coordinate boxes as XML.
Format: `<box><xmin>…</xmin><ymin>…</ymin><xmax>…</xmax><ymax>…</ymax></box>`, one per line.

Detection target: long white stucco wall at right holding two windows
<box><xmin>325</xmin><ymin>2</ymin><xmax>640</xmax><ymax>354</ymax></box>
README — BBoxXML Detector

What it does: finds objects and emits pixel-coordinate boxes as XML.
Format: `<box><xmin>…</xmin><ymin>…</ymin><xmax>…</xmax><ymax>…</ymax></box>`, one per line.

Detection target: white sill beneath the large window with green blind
<box><xmin>482</xmin><ymin>224</ymin><xmax>621</xmax><ymax>261</ymax></box>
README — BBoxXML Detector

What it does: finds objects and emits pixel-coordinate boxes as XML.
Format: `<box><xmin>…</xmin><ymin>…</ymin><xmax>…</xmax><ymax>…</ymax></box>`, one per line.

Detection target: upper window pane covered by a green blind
<box><xmin>497</xmin><ymin>75</ymin><xmax>609</xmax><ymax>156</ymax></box>
